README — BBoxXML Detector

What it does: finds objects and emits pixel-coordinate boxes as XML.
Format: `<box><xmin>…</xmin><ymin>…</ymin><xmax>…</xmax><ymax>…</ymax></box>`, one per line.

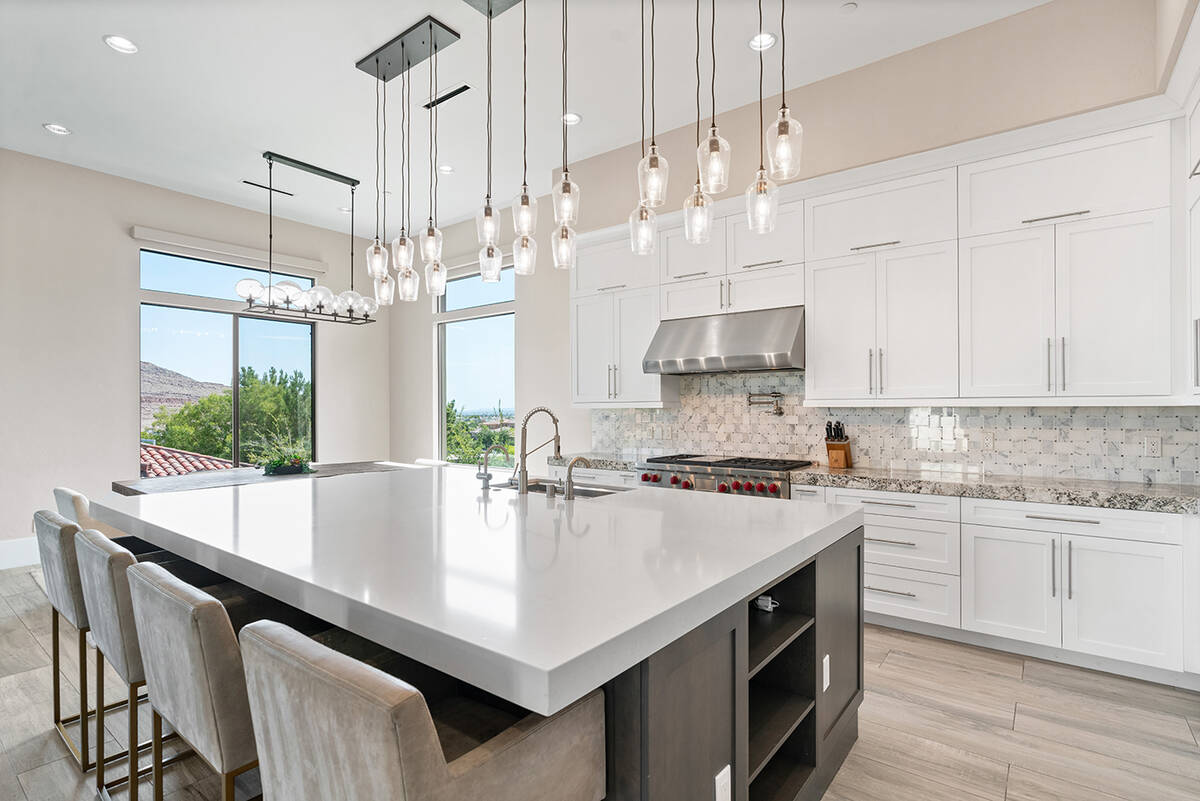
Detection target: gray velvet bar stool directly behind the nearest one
<box><xmin>126</xmin><ymin>562</ymin><xmax>258</xmax><ymax>801</ymax></box>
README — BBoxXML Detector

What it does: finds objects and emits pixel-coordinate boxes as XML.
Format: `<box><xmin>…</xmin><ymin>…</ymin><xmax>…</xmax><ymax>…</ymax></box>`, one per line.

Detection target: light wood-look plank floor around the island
<box><xmin>0</xmin><ymin>568</ymin><xmax>1200</xmax><ymax>801</ymax></box>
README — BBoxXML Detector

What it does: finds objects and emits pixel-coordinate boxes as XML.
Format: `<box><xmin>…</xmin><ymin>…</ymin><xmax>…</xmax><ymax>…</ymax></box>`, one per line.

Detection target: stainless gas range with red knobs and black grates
<box><xmin>637</xmin><ymin>453</ymin><xmax>812</xmax><ymax>498</ymax></box>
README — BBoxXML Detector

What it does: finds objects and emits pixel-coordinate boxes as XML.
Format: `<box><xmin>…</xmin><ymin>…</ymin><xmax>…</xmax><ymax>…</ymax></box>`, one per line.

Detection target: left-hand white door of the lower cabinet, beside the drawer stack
<box><xmin>962</xmin><ymin>525</ymin><xmax>1062</xmax><ymax>648</ymax></box>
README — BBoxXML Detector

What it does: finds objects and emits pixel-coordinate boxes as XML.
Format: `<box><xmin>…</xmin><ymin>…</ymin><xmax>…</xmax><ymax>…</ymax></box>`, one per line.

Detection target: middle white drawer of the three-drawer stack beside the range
<box><xmin>863</xmin><ymin>565</ymin><xmax>961</xmax><ymax>628</ymax></box>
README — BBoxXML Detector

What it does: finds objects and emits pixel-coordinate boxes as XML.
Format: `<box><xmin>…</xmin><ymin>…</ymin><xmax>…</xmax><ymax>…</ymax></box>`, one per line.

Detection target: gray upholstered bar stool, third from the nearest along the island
<box><xmin>74</xmin><ymin>530</ymin><xmax>196</xmax><ymax>801</ymax></box>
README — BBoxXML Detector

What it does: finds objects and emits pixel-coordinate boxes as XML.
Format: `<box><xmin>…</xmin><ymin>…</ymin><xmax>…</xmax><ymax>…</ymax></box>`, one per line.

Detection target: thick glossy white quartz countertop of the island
<box><xmin>92</xmin><ymin>466</ymin><xmax>863</xmax><ymax>715</ymax></box>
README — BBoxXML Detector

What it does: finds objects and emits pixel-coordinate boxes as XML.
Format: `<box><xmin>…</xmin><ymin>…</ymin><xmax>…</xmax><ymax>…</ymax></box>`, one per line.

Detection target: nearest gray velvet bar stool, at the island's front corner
<box><xmin>240</xmin><ymin>618</ymin><xmax>605</xmax><ymax>801</ymax></box>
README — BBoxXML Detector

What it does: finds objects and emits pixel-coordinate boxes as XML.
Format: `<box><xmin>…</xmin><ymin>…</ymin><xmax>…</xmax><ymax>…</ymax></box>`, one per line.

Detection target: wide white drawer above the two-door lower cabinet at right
<box><xmin>962</xmin><ymin>498</ymin><xmax>1183</xmax><ymax>546</ymax></box>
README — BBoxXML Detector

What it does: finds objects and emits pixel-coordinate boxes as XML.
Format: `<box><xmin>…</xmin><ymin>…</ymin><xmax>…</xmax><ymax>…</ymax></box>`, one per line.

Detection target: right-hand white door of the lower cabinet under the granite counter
<box><xmin>1062</xmin><ymin>536</ymin><xmax>1183</xmax><ymax>670</ymax></box>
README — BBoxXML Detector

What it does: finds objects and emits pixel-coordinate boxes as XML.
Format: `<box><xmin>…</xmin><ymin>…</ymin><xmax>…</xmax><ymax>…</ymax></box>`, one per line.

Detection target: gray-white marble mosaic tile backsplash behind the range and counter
<box><xmin>592</xmin><ymin>373</ymin><xmax>1200</xmax><ymax>484</ymax></box>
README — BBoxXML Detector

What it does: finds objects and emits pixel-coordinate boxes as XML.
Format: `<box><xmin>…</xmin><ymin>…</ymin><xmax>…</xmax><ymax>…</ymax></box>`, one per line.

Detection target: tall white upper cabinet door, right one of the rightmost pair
<box><xmin>1055</xmin><ymin>209</ymin><xmax>1171</xmax><ymax>396</ymax></box>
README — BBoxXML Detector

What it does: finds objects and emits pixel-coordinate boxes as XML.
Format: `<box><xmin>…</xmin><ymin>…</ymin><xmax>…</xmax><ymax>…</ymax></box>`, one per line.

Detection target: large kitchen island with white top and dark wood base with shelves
<box><xmin>92</xmin><ymin>466</ymin><xmax>863</xmax><ymax>801</ymax></box>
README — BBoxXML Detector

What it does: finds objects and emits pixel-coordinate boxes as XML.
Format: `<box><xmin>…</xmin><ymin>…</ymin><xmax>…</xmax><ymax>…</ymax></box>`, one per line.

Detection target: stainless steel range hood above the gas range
<box><xmin>642</xmin><ymin>306</ymin><xmax>804</xmax><ymax>375</ymax></box>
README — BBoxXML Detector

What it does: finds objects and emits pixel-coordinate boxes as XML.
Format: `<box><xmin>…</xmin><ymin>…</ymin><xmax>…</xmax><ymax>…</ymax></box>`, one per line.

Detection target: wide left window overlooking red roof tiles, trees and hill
<box><xmin>140</xmin><ymin>251</ymin><xmax>316</xmax><ymax>477</ymax></box>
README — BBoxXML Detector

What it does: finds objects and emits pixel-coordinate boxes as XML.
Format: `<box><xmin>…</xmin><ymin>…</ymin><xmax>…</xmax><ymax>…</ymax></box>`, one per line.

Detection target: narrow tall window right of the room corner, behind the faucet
<box><xmin>436</xmin><ymin>269</ymin><xmax>516</xmax><ymax>468</ymax></box>
